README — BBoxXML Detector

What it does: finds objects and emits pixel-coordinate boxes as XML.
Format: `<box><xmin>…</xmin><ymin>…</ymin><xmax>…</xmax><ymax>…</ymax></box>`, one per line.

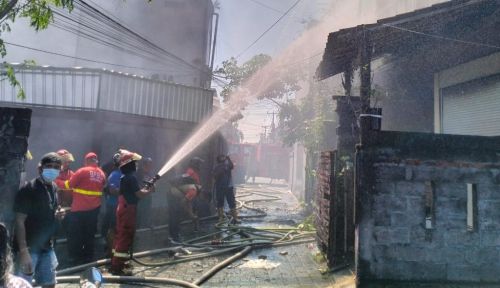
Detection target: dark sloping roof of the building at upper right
<box><xmin>317</xmin><ymin>0</ymin><xmax>500</xmax><ymax>79</ymax></box>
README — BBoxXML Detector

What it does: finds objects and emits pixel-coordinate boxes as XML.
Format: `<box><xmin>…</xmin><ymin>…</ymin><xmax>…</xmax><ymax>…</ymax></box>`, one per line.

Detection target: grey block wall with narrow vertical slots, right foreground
<box><xmin>356</xmin><ymin>131</ymin><xmax>500</xmax><ymax>282</ymax></box>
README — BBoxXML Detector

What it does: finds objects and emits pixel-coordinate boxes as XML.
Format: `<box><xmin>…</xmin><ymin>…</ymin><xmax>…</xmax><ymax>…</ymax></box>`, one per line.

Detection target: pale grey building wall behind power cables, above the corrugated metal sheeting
<box><xmin>2</xmin><ymin>0</ymin><xmax>213</xmax><ymax>87</ymax></box>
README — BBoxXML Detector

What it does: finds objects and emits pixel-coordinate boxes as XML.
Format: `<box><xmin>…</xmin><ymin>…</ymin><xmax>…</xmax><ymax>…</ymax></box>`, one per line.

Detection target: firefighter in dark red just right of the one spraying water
<box><xmin>167</xmin><ymin>157</ymin><xmax>203</xmax><ymax>242</ymax></box>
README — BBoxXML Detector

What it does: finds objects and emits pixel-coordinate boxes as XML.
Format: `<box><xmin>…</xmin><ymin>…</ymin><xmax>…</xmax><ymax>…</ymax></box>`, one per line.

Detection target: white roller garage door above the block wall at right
<box><xmin>441</xmin><ymin>75</ymin><xmax>500</xmax><ymax>136</ymax></box>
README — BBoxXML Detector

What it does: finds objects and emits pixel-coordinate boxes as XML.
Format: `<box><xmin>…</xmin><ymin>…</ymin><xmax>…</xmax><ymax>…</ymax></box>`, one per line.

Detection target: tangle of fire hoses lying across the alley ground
<box><xmin>57</xmin><ymin>187</ymin><xmax>314</xmax><ymax>287</ymax></box>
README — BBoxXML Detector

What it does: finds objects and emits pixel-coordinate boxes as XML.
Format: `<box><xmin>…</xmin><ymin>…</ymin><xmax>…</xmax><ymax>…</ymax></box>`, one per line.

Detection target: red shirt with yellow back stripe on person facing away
<box><xmin>66</xmin><ymin>165</ymin><xmax>106</xmax><ymax>212</ymax></box>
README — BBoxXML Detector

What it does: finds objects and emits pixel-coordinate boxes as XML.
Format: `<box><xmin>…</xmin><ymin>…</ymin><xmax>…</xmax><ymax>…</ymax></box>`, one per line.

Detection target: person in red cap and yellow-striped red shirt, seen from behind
<box><xmin>65</xmin><ymin>152</ymin><xmax>106</xmax><ymax>264</ymax></box>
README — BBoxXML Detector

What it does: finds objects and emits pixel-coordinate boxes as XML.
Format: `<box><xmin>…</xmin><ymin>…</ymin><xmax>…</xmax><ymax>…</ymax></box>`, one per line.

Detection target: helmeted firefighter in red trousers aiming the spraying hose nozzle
<box><xmin>110</xmin><ymin>149</ymin><xmax>154</xmax><ymax>275</ymax></box>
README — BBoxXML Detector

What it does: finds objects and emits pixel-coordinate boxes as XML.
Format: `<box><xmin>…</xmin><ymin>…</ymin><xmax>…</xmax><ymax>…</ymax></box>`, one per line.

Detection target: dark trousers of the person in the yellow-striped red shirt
<box><xmin>68</xmin><ymin>207</ymin><xmax>100</xmax><ymax>264</ymax></box>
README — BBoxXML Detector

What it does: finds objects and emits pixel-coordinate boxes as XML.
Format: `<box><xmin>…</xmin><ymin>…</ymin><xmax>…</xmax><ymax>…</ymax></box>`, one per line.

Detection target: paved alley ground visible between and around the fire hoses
<box><xmin>57</xmin><ymin>183</ymin><xmax>354</xmax><ymax>287</ymax></box>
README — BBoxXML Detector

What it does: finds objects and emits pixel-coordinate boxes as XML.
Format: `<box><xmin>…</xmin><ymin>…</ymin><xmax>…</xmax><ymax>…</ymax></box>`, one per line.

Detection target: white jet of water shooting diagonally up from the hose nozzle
<box><xmin>154</xmin><ymin>0</ymin><xmax>388</xmax><ymax>176</ymax></box>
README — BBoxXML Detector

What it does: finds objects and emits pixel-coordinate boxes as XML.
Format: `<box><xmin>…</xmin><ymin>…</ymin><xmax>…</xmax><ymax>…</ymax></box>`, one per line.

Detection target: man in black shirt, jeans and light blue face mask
<box><xmin>13</xmin><ymin>152</ymin><xmax>64</xmax><ymax>288</ymax></box>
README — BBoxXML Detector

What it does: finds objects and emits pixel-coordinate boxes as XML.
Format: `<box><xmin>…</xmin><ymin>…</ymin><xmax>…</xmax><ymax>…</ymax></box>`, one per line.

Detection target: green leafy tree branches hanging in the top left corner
<box><xmin>0</xmin><ymin>0</ymin><xmax>73</xmax><ymax>99</ymax></box>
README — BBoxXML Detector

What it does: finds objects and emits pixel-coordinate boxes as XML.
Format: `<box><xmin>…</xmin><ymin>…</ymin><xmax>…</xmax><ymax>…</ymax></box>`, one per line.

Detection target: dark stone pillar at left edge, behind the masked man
<box><xmin>0</xmin><ymin>107</ymin><xmax>31</xmax><ymax>227</ymax></box>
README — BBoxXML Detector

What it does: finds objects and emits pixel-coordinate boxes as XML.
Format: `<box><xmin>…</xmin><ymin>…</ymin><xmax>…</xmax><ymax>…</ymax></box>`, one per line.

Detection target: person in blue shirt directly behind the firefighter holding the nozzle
<box><xmin>101</xmin><ymin>151</ymin><xmax>123</xmax><ymax>257</ymax></box>
